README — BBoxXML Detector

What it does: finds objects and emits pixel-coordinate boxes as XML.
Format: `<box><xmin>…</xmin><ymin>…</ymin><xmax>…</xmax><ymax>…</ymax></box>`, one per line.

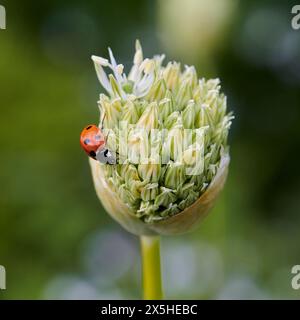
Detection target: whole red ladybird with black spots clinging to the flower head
<box><xmin>80</xmin><ymin>124</ymin><xmax>116</xmax><ymax>164</ymax></box>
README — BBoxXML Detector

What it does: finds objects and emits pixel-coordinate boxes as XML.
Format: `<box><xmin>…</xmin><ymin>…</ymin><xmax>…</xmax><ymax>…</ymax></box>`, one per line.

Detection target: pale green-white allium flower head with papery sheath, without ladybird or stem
<box><xmin>91</xmin><ymin>41</ymin><xmax>233</xmax><ymax>234</ymax></box>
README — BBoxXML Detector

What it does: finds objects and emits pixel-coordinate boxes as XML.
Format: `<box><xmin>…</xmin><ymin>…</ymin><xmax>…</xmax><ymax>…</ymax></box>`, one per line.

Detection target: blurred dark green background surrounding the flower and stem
<box><xmin>0</xmin><ymin>0</ymin><xmax>300</xmax><ymax>299</ymax></box>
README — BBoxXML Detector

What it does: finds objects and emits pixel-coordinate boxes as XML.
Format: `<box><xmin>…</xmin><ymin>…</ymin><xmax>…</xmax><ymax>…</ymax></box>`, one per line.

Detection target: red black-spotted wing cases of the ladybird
<box><xmin>80</xmin><ymin>124</ymin><xmax>105</xmax><ymax>159</ymax></box>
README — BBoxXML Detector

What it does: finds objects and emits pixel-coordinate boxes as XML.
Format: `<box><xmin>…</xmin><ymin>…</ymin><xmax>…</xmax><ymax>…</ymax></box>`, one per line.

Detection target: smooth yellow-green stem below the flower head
<box><xmin>141</xmin><ymin>236</ymin><xmax>163</xmax><ymax>300</ymax></box>
